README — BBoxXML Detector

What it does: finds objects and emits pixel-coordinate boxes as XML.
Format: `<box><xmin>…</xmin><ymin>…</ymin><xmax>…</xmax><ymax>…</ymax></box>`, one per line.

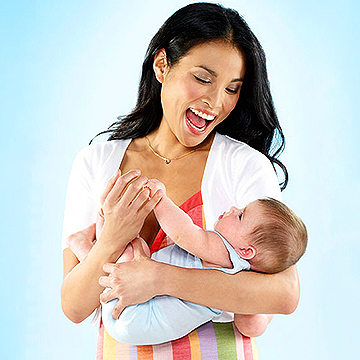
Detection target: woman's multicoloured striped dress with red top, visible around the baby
<box><xmin>96</xmin><ymin>192</ymin><xmax>258</xmax><ymax>360</ymax></box>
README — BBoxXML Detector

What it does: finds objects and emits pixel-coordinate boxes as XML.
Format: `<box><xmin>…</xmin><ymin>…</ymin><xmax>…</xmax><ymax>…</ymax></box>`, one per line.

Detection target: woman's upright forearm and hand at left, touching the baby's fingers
<box><xmin>61</xmin><ymin>172</ymin><xmax>160</xmax><ymax>323</ymax></box>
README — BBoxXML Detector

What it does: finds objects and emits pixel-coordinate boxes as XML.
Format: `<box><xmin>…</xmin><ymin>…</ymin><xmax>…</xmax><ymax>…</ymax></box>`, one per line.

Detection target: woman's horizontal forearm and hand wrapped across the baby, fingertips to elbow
<box><xmin>101</xmin><ymin>256</ymin><xmax>300</xmax><ymax>314</ymax></box>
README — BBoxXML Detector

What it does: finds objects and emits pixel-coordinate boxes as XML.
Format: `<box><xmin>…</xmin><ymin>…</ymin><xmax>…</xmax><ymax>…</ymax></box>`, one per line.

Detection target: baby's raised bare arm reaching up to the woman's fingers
<box><xmin>146</xmin><ymin>179</ymin><xmax>232</xmax><ymax>268</ymax></box>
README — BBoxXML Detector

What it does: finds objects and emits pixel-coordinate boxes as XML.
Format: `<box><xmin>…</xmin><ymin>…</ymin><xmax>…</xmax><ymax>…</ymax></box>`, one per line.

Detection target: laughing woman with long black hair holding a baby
<box><xmin>62</xmin><ymin>3</ymin><xmax>299</xmax><ymax>359</ymax></box>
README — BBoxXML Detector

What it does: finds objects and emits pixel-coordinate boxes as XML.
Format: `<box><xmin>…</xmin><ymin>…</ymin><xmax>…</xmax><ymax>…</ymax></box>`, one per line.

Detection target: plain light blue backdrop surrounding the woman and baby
<box><xmin>0</xmin><ymin>0</ymin><xmax>360</xmax><ymax>360</ymax></box>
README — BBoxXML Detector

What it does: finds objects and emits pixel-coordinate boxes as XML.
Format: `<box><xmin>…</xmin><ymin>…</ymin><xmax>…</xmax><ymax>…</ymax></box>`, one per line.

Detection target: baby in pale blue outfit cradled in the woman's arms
<box><xmin>69</xmin><ymin>180</ymin><xmax>307</xmax><ymax>345</ymax></box>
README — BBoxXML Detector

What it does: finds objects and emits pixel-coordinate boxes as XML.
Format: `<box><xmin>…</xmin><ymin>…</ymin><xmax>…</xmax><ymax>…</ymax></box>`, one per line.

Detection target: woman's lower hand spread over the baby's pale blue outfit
<box><xmin>99</xmin><ymin>238</ymin><xmax>158</xmax><ymax>319</ymax></box>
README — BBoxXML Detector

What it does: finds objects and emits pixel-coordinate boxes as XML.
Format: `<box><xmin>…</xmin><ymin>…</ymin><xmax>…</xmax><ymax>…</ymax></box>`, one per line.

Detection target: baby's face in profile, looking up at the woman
<box><xmin>214</xmin><ymin>201</ymin><xmax>264</xmax><ymax>249</ymax></box>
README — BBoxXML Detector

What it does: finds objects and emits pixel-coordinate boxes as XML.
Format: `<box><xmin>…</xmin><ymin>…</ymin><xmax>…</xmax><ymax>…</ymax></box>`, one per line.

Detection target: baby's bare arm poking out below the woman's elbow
<box><xmin>234</xmin><ymin>314</ymin><xmax>273</xmax><ymax>337</ymax></box>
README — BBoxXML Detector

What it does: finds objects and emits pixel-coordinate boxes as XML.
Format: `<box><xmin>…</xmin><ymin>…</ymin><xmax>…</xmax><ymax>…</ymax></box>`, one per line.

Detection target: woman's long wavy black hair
<box><xmin>94</xmin><ymin>3</ymin><xmax>288</xmax><ymax>190</ymax></box>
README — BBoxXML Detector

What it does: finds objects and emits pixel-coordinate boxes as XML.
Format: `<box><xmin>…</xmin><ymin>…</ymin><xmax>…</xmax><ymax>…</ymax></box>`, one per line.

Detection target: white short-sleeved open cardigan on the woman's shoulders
<box><xmin>62</xmin><ymin>133</ymin><xmax>281</xmax><ymax>249</ymax></box>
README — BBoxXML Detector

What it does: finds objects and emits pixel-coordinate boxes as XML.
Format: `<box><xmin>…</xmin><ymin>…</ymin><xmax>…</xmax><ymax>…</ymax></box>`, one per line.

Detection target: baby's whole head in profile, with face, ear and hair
<box><xmin>214</xmin><ymin>198</ymin><xmax>307</xmax><ymax>273</ymax></box>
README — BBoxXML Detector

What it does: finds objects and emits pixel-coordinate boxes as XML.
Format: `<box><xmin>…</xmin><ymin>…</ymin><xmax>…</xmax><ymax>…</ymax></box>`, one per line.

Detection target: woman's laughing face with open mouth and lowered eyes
<box><xmin>158</xmin><ymin>41</ymin><xmax>245</xmax><ymax>147</ymax></box>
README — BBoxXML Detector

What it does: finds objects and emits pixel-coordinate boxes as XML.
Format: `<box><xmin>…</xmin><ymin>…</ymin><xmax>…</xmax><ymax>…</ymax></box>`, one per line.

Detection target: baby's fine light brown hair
<box><xmin>250</xmin><ymin>198</ymin><xmax>307</xmax><ymax>273</ymax></box>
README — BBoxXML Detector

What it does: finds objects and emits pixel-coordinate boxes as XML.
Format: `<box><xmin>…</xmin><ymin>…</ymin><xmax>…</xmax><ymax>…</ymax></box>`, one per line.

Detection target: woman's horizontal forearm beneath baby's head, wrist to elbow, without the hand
<box><xmin>157</xmin><ymin>266</ymin><xmax>299</xmax><ymax>314</ymax></box>
